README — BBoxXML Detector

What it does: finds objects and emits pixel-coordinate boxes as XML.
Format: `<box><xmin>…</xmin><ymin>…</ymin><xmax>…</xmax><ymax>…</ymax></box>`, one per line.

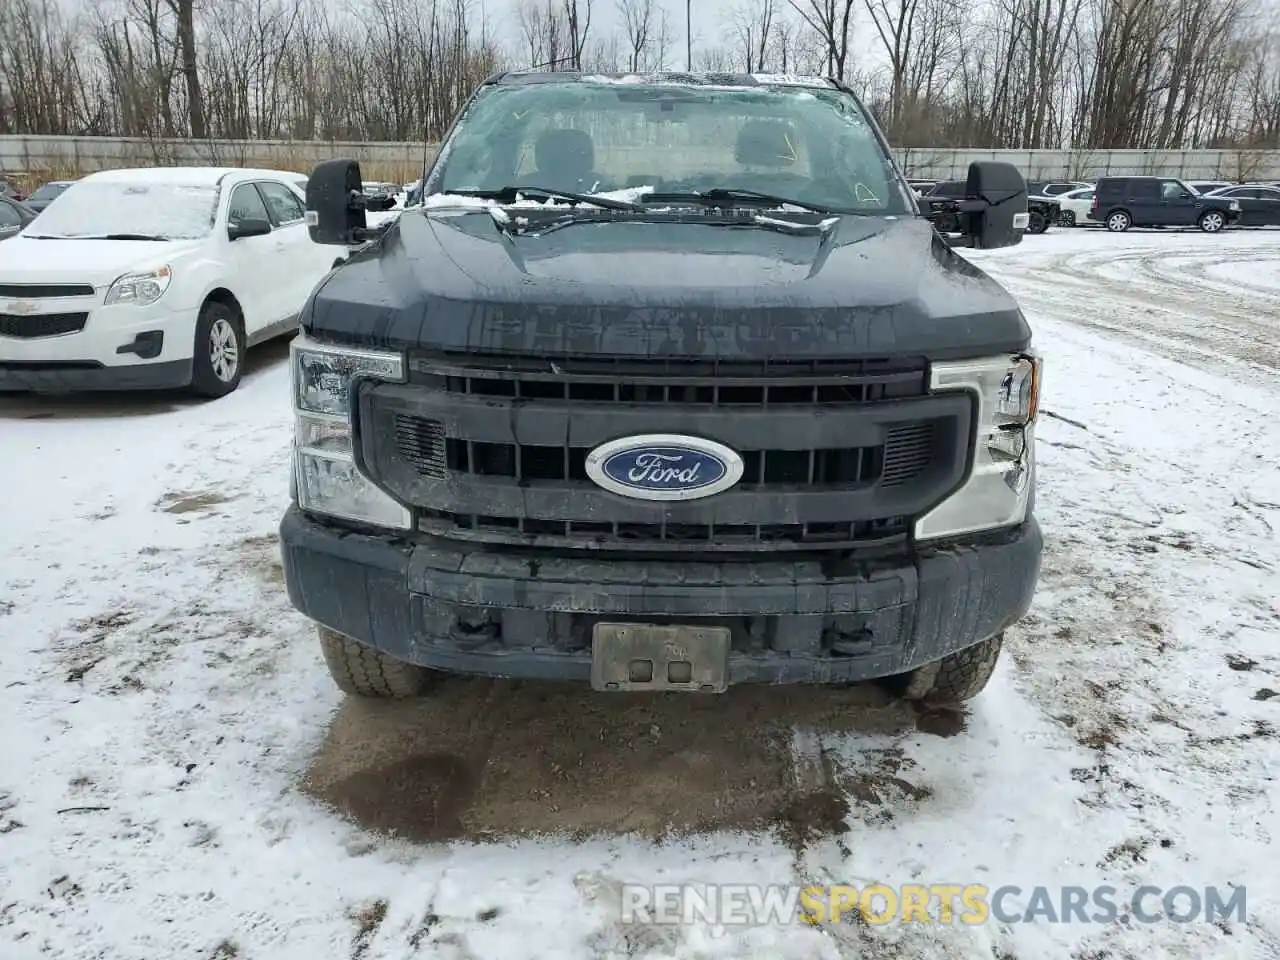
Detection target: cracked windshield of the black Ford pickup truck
<box><xmin>426</xmin><ymin>78</ymin><xmax>910</xmax><ymax>214</ymax></box>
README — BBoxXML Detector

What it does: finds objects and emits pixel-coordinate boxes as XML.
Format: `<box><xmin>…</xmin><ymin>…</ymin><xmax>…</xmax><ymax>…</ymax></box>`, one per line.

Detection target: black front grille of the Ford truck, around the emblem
<box><xmin>356</xmin><ymin>356</ymin><xmax>972</xmax><ymax>553</ymax></box>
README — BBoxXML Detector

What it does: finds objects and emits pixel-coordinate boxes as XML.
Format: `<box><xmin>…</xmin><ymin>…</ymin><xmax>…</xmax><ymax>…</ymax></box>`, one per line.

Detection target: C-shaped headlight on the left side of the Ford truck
<box><xmin>289</xmin><ymin>334</ymin><xmax>413</xmax><ymax>530</ymax></box>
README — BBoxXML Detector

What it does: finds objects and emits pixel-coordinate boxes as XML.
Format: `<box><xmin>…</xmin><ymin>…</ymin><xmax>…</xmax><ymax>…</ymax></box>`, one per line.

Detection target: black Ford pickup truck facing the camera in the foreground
<box><xmin>280</xmin><ymin>73</ymin><xmax>1042</xmax><ymax>703</ymax></box>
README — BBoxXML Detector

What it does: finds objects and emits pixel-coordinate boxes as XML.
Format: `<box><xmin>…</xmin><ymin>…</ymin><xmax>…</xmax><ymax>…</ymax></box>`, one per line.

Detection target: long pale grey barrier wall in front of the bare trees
<box><xmin>0</xmin><ymin>136</ymin><xmax>1280</xmax><ymax>182</ymax></box>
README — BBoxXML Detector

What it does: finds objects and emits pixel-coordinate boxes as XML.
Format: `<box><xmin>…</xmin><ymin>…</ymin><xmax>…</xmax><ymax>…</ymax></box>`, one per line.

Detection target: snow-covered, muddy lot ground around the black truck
<box><xmin>0</xmin><ymin>230</ymin><xmax>1280</xmax><ymax>960</ymax></box>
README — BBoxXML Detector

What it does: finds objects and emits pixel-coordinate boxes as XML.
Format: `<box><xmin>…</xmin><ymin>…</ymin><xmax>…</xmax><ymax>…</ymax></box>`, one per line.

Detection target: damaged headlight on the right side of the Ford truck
<box><xmin>915</xmin><ymin>352</ymin><xmax>1043</xmax><ymax>540</ymax></box>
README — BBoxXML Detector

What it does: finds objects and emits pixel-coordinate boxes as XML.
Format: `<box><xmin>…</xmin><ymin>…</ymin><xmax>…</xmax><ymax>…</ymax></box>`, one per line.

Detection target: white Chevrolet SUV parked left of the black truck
<box><xmin>0</xmin><ymin>168</ymin><xmax>334</xmax><ymax>397</ymax></box>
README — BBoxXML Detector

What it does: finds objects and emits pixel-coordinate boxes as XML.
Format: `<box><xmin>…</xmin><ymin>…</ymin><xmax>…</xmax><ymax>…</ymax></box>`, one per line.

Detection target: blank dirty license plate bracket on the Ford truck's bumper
<box><xmin>591</xmin><ymin>623</ymin><xmax>731</xmax><ymax>694</ymax></box>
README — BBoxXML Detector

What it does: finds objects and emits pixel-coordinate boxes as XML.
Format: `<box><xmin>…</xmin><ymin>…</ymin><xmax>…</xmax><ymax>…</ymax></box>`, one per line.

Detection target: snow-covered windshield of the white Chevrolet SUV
<box><xmin>31</xmin><ymin>180</ymin><xmax>218</xmax><ymax>239</ymax></box>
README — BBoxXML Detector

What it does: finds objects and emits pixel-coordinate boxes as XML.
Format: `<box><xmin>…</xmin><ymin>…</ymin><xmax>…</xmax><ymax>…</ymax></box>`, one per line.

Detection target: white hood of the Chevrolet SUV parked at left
<box><xmin>0</xmin><ymin>233</ymin><xmax>201</xmax><ymax>287</ymax></box>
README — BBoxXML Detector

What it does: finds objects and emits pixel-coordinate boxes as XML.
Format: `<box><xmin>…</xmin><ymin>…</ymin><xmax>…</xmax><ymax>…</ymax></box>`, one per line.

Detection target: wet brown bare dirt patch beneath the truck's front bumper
<box><xmin>303</xmin><ymin>677</ymin><xmax>915</xmax><ymax>844</ymax></box>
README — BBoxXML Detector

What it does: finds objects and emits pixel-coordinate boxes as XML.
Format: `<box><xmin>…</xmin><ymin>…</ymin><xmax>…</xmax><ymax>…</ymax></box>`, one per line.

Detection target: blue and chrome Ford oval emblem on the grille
<box><xmin>586</xmin><ymin>434</ymin><xmax>742</xmax><ymax>500</ymax></box>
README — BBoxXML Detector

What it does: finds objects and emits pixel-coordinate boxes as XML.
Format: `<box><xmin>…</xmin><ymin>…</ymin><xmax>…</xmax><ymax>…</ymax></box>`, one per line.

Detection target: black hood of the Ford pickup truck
<box><xmin>302</xmin><ymin>210</ymin><xmax>1030</xmax><ymax>358</ymax></box>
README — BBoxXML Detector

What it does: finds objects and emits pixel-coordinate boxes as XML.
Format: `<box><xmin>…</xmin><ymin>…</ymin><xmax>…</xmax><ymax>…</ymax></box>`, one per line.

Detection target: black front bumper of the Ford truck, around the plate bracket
<box><xmin>280</xmin><ymin>506</ymin><xmax>1043</xmax><ymax>684</ymax></box>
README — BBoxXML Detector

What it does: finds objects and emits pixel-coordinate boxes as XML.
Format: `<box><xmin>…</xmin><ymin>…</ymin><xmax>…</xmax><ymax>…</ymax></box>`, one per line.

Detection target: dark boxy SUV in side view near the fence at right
<box><xmin>1089</xmin><ymin>177</ymin><xmax>1240</xmax><ymax>233</ymax></box>
